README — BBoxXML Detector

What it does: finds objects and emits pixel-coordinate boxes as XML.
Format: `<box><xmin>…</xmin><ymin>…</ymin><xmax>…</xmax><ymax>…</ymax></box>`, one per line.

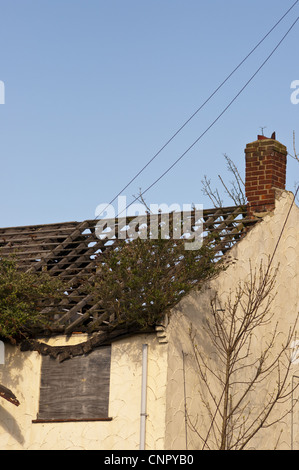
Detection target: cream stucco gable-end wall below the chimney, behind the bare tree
<box><xmin>166</xmin><ymin>191</ymin><xmax>299</xmax><ymax>449</ymax></box>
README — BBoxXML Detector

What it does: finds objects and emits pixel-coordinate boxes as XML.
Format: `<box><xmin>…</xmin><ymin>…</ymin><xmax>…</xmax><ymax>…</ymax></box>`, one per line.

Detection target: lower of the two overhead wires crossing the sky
<box><xmin>117</xmin><ymin>12</ymin><xmax>299</xmax><ymax>217</ymax></box>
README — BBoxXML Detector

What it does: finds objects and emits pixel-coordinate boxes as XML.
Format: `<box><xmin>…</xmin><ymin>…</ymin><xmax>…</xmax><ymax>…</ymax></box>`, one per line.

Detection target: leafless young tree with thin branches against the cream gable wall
<box><xmin>189</xmin><ymin>260</ymin><xmax>297</xmax><ymax>449</ymax></box>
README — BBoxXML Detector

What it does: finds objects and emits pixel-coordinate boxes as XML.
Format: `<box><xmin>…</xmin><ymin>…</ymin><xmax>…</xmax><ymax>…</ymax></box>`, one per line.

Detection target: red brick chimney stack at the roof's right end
<box><xmin>245</xmin><ymin>134</ymin><xmax>287</xmax><ymax>216</ymax></box>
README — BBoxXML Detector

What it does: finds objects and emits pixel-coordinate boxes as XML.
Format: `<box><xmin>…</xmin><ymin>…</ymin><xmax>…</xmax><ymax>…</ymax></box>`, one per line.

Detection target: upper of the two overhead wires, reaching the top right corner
<box><xmin>96</xmin><ymin>0</ymin><xmax>299</xmax><ymax>218</ymax></box>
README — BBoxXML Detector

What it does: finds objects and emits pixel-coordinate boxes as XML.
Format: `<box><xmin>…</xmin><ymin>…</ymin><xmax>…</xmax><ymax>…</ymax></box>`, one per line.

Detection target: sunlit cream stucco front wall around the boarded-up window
<box><xmin>0</xmin><ymin>335</ymin><xmax>167</xmax><ymax>450</ymax></box>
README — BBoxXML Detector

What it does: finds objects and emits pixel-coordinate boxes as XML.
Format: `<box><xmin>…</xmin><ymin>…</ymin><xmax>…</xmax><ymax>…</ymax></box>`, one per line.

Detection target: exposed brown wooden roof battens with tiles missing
<box><xmin>0</xmin><ymin>206</ymin><xmax>257</xmax><ymax>335</ymax></box>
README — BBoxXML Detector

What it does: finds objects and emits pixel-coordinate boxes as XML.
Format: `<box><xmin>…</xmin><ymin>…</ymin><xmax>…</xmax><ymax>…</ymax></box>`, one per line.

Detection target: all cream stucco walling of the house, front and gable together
<box><xmin>0</xmin><ymin>191</ymin><xmax>299</xmax><ymax>450</ymax></box>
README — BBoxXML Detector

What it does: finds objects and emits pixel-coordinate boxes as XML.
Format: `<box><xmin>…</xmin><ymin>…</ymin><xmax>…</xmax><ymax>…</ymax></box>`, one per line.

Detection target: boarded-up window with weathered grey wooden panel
<box><xmin>38</xmin><ymin>346</ymin><xmax>111</xmax><ymax>420</ymax></box>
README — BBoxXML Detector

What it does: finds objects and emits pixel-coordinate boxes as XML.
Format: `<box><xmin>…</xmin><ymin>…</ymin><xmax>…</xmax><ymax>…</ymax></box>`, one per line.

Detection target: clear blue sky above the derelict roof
<box><xmin>0</xmin><ymin>0</ymin><xmax>299</xmax><ymax>227</ymax></box>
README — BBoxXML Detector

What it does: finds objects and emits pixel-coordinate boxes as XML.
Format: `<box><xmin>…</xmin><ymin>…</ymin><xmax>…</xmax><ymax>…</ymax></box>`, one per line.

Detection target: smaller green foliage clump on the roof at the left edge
<box><xmin>0</xmin><ymin>258</ymin><xmax>62</xmax><ymax>342</ymax></box>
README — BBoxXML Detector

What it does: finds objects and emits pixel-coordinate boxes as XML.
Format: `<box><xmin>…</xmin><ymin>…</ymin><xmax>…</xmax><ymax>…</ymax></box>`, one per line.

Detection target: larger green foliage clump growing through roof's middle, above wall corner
<box><xmin>95</xmin><ymin>238</ymin><xmax>219</xmax><ymax>328</ymax></box>
